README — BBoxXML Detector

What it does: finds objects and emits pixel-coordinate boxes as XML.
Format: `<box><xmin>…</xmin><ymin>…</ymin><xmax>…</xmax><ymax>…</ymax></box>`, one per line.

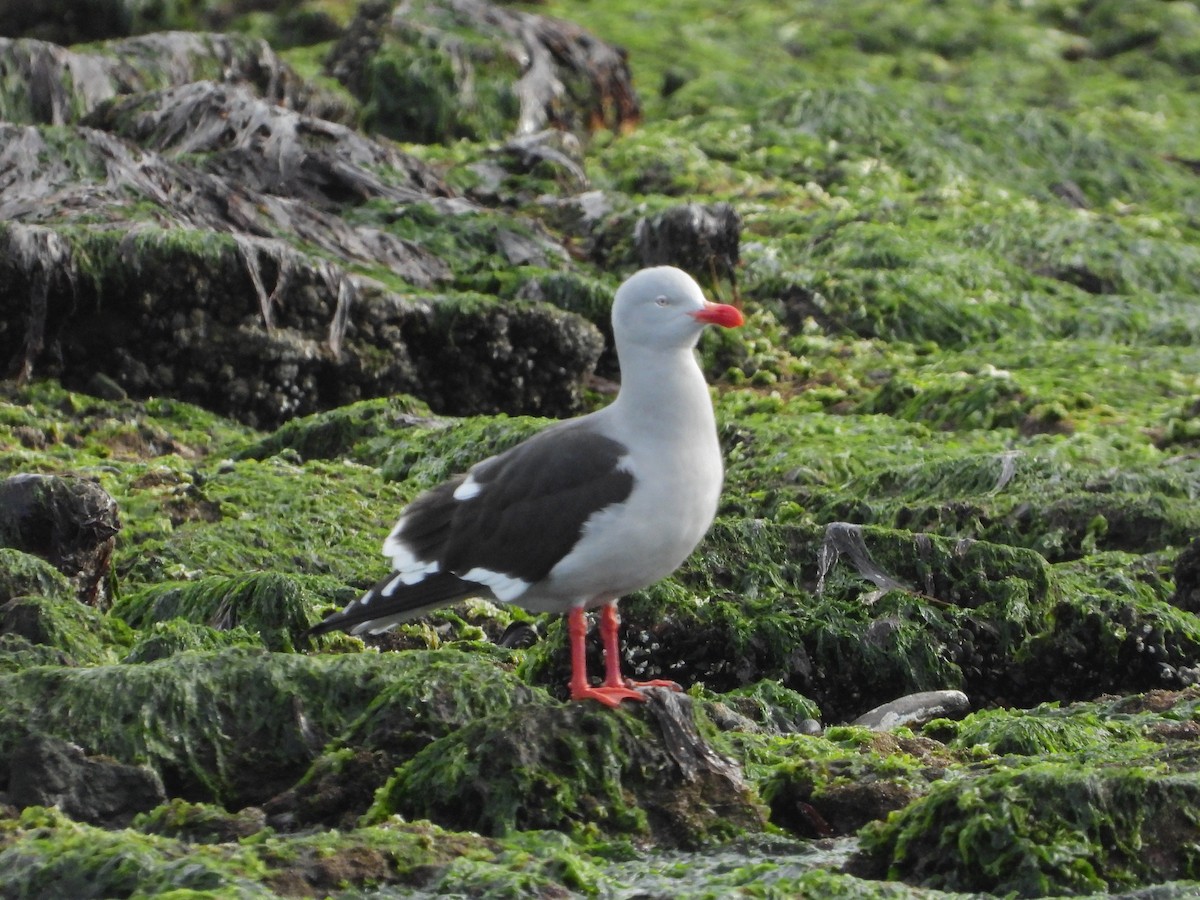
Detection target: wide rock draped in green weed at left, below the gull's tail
<box><xmin>0</xmin><ymin>648</ymin><xmax>528</xmax><ymax>809</ymax></box>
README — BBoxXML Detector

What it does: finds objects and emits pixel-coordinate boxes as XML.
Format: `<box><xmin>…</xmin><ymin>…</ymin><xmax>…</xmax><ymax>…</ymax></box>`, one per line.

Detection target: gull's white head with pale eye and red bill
<box><xmin>612</xmin><ymin>265</ymin><xmax>743</xmax><ymax>349</ymax></box>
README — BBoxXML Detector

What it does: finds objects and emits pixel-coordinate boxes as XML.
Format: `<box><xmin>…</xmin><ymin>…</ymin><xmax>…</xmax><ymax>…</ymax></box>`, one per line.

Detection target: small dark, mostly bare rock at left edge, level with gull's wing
<box><xmin>0</xmin><ymin>474</ymin><xmax>121</xmax><ymax>608</ymax></box>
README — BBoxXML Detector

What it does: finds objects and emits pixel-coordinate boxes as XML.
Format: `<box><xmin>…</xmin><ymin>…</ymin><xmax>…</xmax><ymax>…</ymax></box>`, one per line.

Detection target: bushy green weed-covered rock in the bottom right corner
<box><xmin>860</xmin><ymin>761</ymin><xmax>1200</xmax><ymax>896</ymax></box>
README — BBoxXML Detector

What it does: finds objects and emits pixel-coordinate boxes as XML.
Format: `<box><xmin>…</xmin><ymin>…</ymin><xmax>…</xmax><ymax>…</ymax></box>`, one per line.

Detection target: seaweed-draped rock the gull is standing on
<box><xmin>370</xmin><ymin>690</ymin><xmax>762</xmax><ymax>847</ymax></box>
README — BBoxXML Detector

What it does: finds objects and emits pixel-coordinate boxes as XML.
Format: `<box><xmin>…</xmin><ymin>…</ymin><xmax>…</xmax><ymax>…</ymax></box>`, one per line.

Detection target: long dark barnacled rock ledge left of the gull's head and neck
<box><xmin>0</xmin><ymin>220</ymin><xmax>602</xmax><ymax>426</ymax></box>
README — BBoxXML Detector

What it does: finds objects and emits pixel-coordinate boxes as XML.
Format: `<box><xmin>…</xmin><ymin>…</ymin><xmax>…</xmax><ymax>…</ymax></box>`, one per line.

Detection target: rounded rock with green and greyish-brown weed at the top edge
<box><xmin>326</xmin><ymin>0</ymin><xmax>640</xmax><ymax>143</ymax></box>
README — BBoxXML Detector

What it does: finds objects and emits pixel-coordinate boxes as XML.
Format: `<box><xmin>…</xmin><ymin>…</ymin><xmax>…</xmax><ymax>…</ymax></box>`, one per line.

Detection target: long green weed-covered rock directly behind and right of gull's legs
<box><xmin>540</xmin><ymin>518</ymin><xmax>1056</xmax><ymax>721</ymax></box>
